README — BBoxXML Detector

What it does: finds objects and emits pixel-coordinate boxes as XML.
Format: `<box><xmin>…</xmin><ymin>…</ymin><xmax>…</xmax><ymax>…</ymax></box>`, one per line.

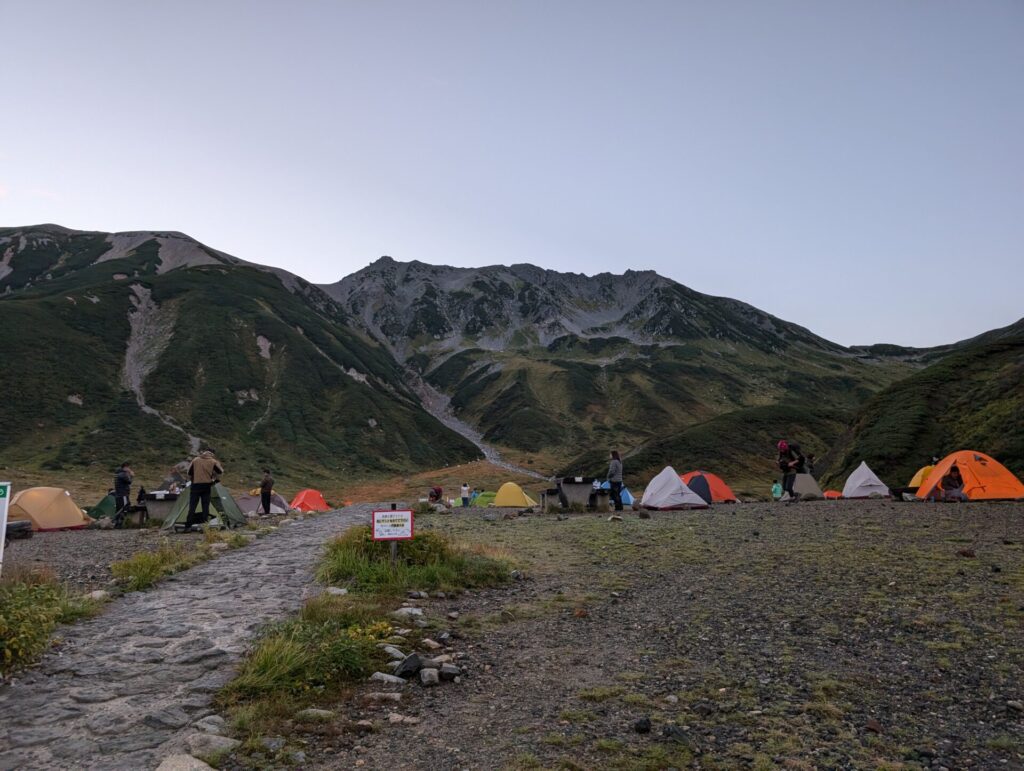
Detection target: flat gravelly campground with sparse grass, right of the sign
<box><xmin>313</xmin><ymin>501</ymin><xmax>1024</xmax><ymax>769</ymax></box>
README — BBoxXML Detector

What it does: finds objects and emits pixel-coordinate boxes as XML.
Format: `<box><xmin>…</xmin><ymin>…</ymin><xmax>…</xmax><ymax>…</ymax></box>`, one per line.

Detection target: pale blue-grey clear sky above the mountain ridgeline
<box><xmin>0</xmin><ymin>0</ymin><xmax>1024</xmax><ymax>346</ymax></box>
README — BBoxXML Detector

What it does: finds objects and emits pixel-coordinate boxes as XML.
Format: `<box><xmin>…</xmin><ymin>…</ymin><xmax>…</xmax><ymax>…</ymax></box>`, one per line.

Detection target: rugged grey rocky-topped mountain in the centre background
<box><xmin>324</xmin><ymin>258</ymin><xmax>918</xmax><ymax>462</ymax></box>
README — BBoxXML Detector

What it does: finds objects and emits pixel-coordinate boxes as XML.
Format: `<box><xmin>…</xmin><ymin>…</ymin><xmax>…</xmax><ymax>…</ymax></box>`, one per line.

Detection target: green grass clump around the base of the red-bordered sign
<box><xmin>317</xmin><ymin>526</ymin><xmax>509</xmax><ymax>596</ymax></box>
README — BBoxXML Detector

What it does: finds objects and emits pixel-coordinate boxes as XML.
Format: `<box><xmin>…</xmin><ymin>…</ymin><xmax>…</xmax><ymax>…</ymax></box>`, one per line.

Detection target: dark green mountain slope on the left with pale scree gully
<box><xmin>0</xmin><ymin>226</ymin><xmax>478</xmax><ymax>474</ymax></box>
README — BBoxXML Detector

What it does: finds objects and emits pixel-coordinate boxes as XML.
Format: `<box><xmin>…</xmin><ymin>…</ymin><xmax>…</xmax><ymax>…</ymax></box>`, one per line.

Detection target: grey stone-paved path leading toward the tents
<box><xmin>0</xmin><ymin>504</ymin><xmax>378</xmax><ymax>771</ymax></box>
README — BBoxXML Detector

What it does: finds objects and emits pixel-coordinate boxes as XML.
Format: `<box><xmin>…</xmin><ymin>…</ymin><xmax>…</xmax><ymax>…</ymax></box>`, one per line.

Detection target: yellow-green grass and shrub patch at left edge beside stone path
<box><xmin>0</xmin><ymin>570</ymin><xmax>100</xmax><ymax>674</ymax></box>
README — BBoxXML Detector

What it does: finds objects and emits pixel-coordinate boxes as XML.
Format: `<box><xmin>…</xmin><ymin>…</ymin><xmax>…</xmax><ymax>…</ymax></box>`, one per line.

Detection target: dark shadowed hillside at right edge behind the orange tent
<box><xmin>827</xmin><ymin>319</ymin><xmax>1024</xmax><ymax>486</ymax></box>
